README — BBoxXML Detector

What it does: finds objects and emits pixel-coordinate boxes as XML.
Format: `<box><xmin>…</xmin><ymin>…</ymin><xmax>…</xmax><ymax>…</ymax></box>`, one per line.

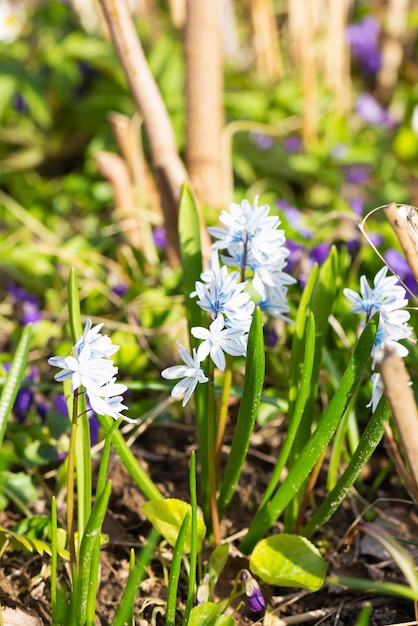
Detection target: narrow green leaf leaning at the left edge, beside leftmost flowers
<box><xmin>0</xmin><ymin>324</ymin><xmax>32</xmax><ymax>446</ymax></box>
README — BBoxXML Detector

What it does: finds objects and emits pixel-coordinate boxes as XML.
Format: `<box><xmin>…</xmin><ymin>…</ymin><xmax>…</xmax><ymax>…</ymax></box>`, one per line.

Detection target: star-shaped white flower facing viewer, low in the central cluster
<box><xmin>191</xmin><ymin>315</ymin><xmax>245</xmax><ymax>372</ymax></box>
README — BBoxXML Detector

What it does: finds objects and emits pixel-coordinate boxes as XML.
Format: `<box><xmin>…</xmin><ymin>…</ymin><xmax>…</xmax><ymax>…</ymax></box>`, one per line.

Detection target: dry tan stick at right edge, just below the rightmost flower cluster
<box><xmin>377</xmin><ymin>346</ymin><xmax>418</xmax><ymax>502</ymax></box>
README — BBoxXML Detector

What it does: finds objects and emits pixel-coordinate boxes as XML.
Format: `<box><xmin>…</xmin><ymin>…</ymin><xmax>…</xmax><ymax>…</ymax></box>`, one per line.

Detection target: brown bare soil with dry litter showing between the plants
<box><xmin>0</xmin><ymin>422</ymin><xmax>418</xmax><ymax>626</ymax></box>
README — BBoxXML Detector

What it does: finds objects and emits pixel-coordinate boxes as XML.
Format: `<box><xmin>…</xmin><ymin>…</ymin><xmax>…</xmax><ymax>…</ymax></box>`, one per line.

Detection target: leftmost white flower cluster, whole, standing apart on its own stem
<box><xmin>48</xmin><ymin>320</ymin><xmax>131</xmax><ymax>422</ymax></box>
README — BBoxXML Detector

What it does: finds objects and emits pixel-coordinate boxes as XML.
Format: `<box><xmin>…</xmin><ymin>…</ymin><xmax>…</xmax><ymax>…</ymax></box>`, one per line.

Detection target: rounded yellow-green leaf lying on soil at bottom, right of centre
<box><xmin>250</xmin><ymin>533</ymin><xmax>327</xmax><ymax>591</ymax></box>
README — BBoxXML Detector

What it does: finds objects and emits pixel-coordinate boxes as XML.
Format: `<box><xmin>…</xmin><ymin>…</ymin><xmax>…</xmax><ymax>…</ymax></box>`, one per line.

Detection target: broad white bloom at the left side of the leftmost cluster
<box><xmin>48</xmin><ymin>345</ymin><xmax>118</xmax><ymax>391</ymax></box>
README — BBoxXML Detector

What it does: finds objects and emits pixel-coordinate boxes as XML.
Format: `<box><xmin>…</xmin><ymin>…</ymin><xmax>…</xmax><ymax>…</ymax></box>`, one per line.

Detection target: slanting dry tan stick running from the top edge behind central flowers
<box><xmin>100</xmin><ymin>0</ymin><xmax>187</xmax><ymax>265</ymax></box>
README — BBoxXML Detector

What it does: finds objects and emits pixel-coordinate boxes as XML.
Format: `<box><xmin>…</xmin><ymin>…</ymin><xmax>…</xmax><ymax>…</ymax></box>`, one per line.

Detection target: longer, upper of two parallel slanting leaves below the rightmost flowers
<box><xmin>239</xmin><ymin>319</ymin><xmax>376</xmax><ymax>553</ymax></box>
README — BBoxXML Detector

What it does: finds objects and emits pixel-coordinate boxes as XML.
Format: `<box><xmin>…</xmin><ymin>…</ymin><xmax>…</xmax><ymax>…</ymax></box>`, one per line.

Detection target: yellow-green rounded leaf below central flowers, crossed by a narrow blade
<box><xmin>142</xmin><ymin>498</ymin><xmax>206</xmax><ymax>552</ymax></box>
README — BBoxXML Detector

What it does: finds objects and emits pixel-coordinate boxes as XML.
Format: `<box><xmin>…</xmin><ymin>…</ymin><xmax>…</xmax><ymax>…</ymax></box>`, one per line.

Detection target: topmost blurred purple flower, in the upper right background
<box><xmin>346</xmin><ymin>15</ymin><xmax>382</xmax><ymax>76</ymax></box>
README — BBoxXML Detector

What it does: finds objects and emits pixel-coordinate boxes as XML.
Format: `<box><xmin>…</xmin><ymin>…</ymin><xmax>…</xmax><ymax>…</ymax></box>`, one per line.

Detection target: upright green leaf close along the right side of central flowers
<box><xmin>218</xmin><ymin>309</ymin><xmax>265</xmax><ymax>517</ymax></box>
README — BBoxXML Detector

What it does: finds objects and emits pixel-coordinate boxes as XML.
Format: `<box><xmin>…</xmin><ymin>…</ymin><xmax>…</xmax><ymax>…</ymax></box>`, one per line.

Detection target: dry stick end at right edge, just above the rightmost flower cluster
<box><xmin>385</xmin><ymin>203</ymin><xmax>418</xmax><ymax>281</ymax></box>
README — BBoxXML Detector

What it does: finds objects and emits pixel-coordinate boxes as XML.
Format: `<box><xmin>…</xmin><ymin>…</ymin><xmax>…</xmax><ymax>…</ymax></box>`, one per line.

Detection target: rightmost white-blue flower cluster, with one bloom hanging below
<box><xmin>344</xmin><ymin>266</ymin><xmax>412</xmax><ymax>411</ymax></box>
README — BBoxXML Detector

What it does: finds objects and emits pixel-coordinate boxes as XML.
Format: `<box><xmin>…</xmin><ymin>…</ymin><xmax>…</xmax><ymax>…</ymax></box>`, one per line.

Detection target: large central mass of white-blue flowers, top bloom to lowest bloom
<box><xmin>161</xmin><ymin>198</ymin><xmax>296</xmax><ymax>406</ymax></box>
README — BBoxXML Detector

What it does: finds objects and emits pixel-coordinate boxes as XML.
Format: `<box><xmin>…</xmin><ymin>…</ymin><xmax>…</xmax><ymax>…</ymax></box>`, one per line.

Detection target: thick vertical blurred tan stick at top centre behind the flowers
<box><xmin>184</xmin><ymin>0</ymin><xmax>227</xmax><ymax>207</ymax></box>
